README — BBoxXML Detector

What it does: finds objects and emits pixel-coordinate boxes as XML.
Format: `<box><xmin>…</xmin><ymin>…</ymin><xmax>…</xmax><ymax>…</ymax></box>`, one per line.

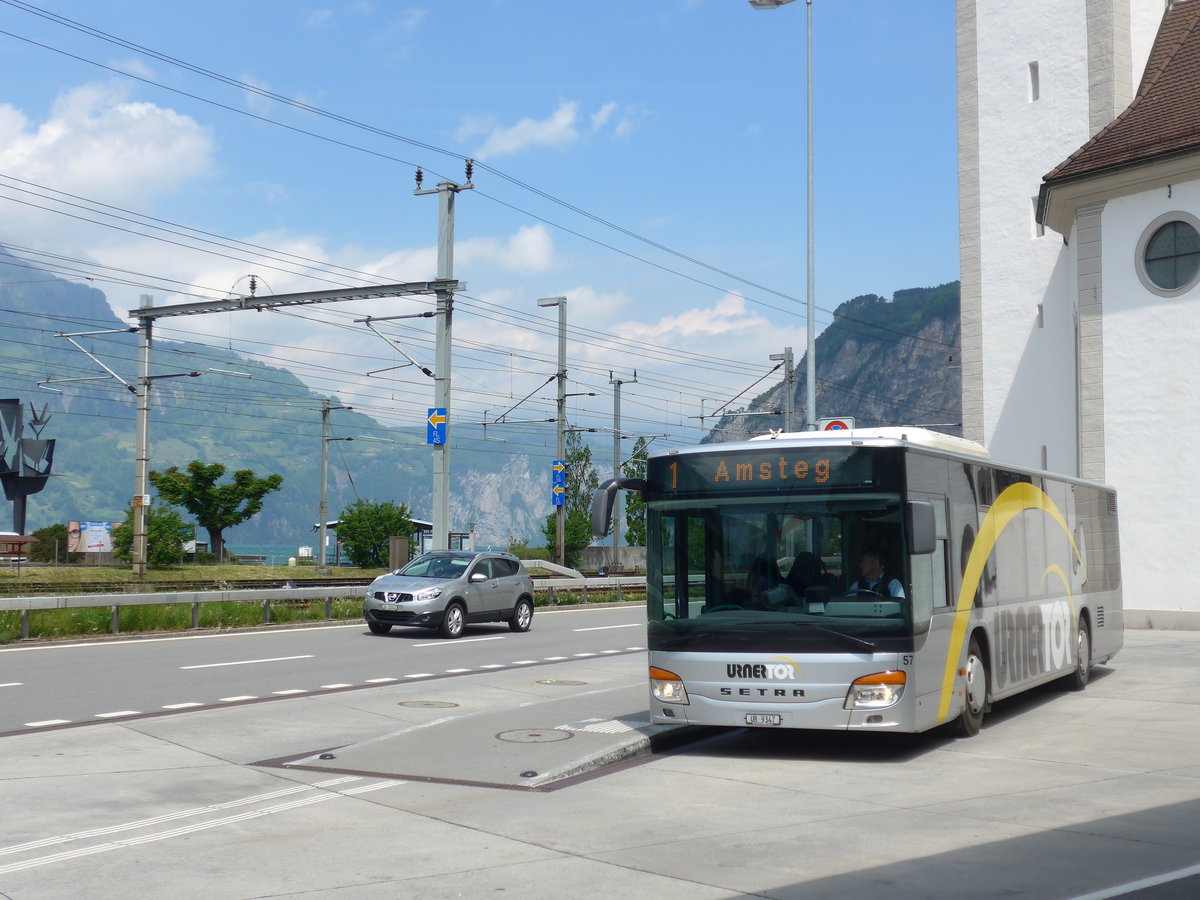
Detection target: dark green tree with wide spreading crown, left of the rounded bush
<box><xmin>150</xmin><ymin>460</ymin><xmax>283</xmax><ymax>559</ymax></box>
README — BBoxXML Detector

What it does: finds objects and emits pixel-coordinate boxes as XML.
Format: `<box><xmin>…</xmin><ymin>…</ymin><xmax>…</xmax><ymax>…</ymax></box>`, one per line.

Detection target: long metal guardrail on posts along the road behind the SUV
<box><xmin>0</xmin><ymin>576</ymin><xmax>646</xmax><ymax>640</ymax></box>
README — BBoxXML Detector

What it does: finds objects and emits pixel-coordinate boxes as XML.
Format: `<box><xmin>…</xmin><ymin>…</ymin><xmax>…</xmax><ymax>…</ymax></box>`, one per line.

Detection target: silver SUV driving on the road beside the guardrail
<box><xmin>362</xmin><ymin>550</ymin><xmax>533</xmax><ymax>637</ymax></box>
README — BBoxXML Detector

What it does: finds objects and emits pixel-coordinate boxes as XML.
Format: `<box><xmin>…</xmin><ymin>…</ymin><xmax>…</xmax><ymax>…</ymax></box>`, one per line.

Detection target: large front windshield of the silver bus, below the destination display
<box><xmin>647</xmin><ymin>491</ymin><xmax>912</xmax><ymax>653</ymax></box>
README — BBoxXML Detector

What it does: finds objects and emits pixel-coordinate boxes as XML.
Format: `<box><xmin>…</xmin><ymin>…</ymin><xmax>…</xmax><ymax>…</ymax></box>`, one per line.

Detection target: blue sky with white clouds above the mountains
<box><xmin>0</xmin><ymin>0</ymin><xmax>959</xmax><ymax>458</ymax></box>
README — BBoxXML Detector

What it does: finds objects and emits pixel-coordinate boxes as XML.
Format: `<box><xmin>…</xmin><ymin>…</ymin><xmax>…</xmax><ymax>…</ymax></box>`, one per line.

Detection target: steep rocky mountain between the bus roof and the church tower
<box><xmin>704</xmin><ymin>281</ymin><xmax>962</xmax><ymax>443</ymax></box>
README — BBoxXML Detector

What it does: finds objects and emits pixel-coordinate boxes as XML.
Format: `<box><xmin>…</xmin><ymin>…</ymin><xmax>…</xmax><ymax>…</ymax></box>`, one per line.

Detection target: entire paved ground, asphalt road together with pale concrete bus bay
<box><xmin>0</xmin><ymin>608</ymin><xmax>1200</xmax><ymax>900</ymax></box>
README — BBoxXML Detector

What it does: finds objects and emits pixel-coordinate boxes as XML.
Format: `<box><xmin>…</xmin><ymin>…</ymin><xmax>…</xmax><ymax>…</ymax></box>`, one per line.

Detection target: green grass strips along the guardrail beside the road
<box><xmin>0</xmin><ymin>565</ymin><xmax>646</xmax><ymax>644</ymax></box>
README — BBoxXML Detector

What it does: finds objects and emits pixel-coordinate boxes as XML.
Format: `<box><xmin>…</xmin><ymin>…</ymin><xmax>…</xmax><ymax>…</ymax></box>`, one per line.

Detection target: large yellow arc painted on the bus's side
<box><xmin>937</xmin><ymin>481</ymin><xmax>1082</xmax><ymax>721</ymax></box>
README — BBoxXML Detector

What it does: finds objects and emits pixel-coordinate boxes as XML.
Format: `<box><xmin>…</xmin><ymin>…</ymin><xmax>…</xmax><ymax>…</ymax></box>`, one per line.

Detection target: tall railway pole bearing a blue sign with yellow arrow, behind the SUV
<box><xmin>413</xmin><ymin>160</ymin><xmax>474</xmax><ymax>550</ymax></box>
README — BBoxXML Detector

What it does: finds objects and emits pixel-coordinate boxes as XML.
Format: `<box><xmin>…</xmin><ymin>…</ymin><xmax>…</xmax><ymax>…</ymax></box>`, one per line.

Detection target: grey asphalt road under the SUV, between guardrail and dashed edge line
<box><xmin>0</xmin><ymin>606</ymin><xmax>646</xmax><ymax>734</ymax></box>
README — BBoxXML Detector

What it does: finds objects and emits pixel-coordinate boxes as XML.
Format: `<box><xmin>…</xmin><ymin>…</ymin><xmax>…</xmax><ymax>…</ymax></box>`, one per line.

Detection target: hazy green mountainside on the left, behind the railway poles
<box><xmin>0</xmin><ymin>256</ymin><xmax>554</xmax><ymax>546</ymax></box>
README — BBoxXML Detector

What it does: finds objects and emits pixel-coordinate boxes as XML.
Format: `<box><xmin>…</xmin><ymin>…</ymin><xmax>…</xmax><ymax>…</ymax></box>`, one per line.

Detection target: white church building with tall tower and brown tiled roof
<box><xmin>956</xmin><ymin>0</ymin><xmax>1200</xmax><ymax>628</ymax></box>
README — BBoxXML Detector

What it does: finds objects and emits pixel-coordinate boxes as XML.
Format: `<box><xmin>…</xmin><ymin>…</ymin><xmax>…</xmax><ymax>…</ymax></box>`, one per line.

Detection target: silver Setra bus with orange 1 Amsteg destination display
<box><xmin>593</xmin><ymin>427</ymin><xmax>1123</xmax><ymax>736</ymax></box>
